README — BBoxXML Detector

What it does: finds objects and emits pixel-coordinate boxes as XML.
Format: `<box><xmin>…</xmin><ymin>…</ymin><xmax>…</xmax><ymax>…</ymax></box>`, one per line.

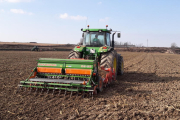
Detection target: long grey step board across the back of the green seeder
<box><xmin>29</xmin><ymin>78</ymin><xmax>84</xmax><ymax>84</ymax></box>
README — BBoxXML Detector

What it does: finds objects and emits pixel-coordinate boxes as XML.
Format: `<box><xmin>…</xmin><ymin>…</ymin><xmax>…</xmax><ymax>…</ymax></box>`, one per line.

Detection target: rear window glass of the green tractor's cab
<box><xmin>83</xmin><ymin>32</ymin><xmax>105</xmax><ymax>46</ymax></box>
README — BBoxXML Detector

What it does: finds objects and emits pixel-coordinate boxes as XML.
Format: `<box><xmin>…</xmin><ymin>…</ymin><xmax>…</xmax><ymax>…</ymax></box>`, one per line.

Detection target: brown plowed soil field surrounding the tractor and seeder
<box><xmin>0</xmin><ymin>51</ymin><xmax>180</xmax><ymax>120</ymax></box>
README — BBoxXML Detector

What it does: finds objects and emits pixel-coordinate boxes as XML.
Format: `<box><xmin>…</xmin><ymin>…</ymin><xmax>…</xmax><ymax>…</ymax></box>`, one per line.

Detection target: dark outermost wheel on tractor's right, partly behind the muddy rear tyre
<box><xmin>117</xmin><ymin>54</ymin><xmax>124</xmax><ymax>75</ymax></box>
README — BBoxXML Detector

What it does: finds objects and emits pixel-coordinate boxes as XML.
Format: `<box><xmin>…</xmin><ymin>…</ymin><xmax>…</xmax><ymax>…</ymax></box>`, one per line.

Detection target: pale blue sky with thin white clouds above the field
<box><xmin>0</xmin><ymin>0</ymin><xmax>180</xmax><ymax>47</ymax></box>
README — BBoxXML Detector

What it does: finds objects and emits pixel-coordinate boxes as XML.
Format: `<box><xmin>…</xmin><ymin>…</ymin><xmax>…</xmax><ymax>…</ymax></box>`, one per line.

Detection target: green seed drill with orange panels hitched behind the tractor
<box><xmin>19</xmin><ymin>58</ymin><xmax>108</xmax><ymax>95</ymax></box>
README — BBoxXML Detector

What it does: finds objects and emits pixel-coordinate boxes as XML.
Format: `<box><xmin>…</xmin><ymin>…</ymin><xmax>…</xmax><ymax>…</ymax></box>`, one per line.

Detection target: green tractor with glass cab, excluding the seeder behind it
<box><xmin>68</xmin><ymin>26</ymin><xmax>124</xmax><ymax>75</ymax></box>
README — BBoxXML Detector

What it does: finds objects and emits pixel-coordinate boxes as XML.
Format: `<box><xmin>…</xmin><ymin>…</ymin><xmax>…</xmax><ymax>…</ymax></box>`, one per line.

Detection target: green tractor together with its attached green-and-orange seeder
<box><xmin>17</xmin><ymin>25</ymin><xmax>124</xmax><ymax>97</ymax></box>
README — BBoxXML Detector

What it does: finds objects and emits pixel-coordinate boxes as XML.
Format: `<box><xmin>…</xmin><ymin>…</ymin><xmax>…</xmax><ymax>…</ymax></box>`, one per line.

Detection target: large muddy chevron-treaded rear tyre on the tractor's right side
<box><xmin>100</xmin><ymin>50</ymin><xmax>117</xmax><ymax>75</ymax></box>
